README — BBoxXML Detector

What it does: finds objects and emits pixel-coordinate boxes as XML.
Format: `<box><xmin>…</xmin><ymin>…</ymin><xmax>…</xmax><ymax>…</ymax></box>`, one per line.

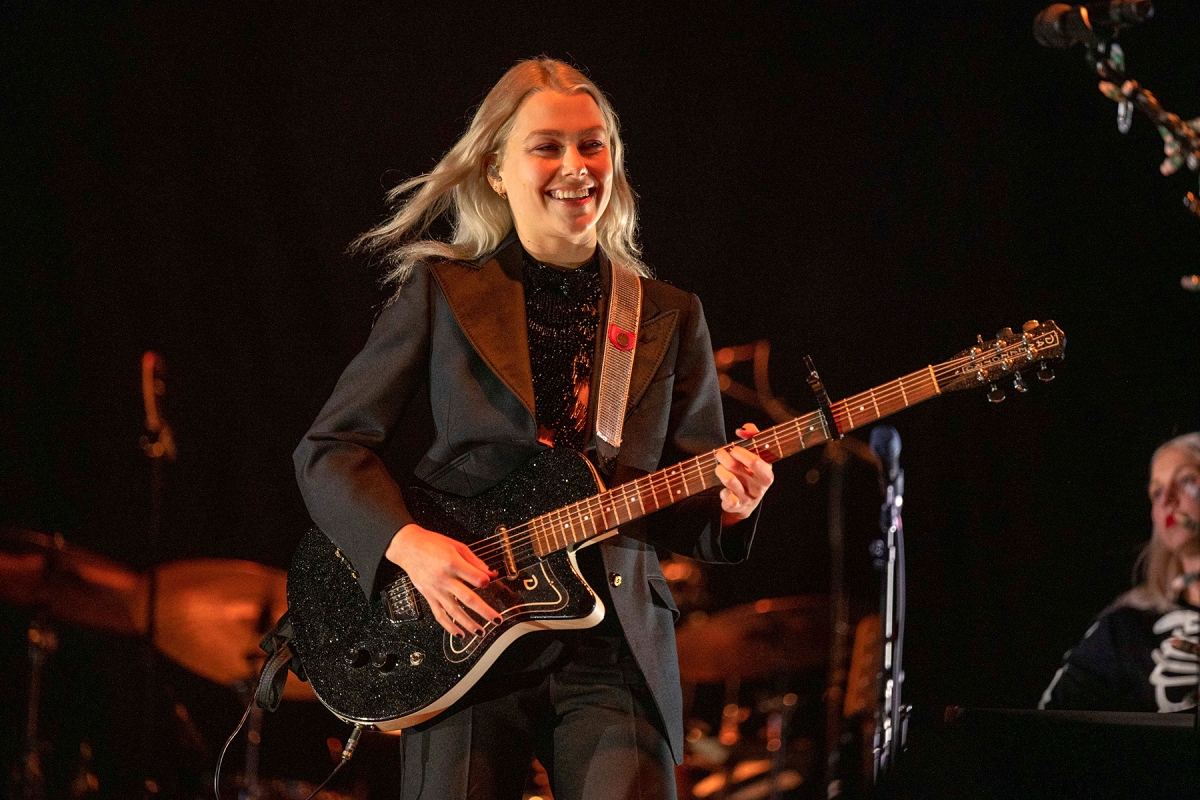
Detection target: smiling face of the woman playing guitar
<box><xmin>488</xmin><ymin>90</ymin><xmax>612</xmax><ymax>266</ymax></box>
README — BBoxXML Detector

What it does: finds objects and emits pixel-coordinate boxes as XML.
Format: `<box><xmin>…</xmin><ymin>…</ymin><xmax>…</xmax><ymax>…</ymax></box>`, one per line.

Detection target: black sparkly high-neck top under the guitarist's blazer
<box><xmin>521</xmin><ymin>251</ymin><xmax>601</xmax><ymax>452</ymax></box>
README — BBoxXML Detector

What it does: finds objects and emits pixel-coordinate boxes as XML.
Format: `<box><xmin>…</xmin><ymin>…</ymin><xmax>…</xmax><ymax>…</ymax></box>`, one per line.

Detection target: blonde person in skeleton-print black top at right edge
<box><xmin>1038</xmin><ymin>432</ymin><xmax>1200</xmax><ymax>711</ymax></box>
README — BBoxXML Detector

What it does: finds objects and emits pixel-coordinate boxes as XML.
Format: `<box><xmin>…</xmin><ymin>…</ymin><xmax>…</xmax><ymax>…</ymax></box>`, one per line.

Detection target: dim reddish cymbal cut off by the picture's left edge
<box><xmin>0</xmin><ymin>528</ymin><xmax>145</xmax><ymax>634</ymax></box>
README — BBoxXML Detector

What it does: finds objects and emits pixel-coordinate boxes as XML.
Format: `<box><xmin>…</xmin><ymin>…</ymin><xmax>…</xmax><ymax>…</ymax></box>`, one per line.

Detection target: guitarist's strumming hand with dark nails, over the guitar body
<box><xmin>384</xmin><ymin>523</ymin><xmax>500</xmax><ymax>638</ymax></box>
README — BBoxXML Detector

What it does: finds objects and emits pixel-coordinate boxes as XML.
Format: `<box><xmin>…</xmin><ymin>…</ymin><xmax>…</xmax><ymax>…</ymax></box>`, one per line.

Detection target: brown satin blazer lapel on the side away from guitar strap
<box><xmin>430</xmin><ymin>236</ymin><xmax>536</xmax><ymax>419</ymax></box>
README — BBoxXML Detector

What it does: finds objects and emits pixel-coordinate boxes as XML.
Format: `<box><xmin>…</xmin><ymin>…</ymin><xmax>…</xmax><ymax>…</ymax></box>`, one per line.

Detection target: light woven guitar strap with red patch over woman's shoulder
<box><xmin>596</xmin><ymin>264</ymin><xmax>642</xmax><ymax>473</ymax></box>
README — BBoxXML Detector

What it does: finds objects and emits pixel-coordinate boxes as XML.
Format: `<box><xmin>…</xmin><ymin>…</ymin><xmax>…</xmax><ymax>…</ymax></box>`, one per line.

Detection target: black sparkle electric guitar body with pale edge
<box><xmin>288</xmin><ymin>449</ymin><xmax>605</xmax><ymax>730</ymax></box>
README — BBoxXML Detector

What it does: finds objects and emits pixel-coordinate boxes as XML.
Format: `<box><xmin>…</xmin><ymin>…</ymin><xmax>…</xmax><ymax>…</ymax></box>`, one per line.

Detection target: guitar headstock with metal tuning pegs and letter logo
<box><xmin>934</xmin><ymin>319</ymin><xmax>1067</xmax><ymax>403</ymax></box>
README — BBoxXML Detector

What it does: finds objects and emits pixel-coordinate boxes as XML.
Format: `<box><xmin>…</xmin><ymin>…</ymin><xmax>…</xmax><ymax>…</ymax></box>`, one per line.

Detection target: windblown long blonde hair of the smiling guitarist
<box><xmin>350</xmin><ymin>58</ymin><xmax>649</xmax><ymax>293</ymax></box>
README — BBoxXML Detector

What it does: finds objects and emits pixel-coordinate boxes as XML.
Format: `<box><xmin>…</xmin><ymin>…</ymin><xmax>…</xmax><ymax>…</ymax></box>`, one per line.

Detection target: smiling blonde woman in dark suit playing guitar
<box><xmin>295</xmin><ymin>58</ymin><xmax>773</xmax><ymax>800</ymax></box>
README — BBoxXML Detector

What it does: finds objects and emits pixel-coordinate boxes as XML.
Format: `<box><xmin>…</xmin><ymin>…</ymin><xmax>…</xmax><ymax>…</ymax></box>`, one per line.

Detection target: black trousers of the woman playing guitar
<box><xmin>401</xmin><ymin>670</ymin><xmax>676</xmax><ymax>800</ymax></box>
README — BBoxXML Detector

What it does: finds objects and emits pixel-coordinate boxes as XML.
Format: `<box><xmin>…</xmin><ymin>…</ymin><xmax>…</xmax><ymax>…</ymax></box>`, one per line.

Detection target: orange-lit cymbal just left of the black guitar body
<box><xmin>152</xmin><ymin>559</ymin><xmax>314</xmax><ymax>700</ymax></box>
